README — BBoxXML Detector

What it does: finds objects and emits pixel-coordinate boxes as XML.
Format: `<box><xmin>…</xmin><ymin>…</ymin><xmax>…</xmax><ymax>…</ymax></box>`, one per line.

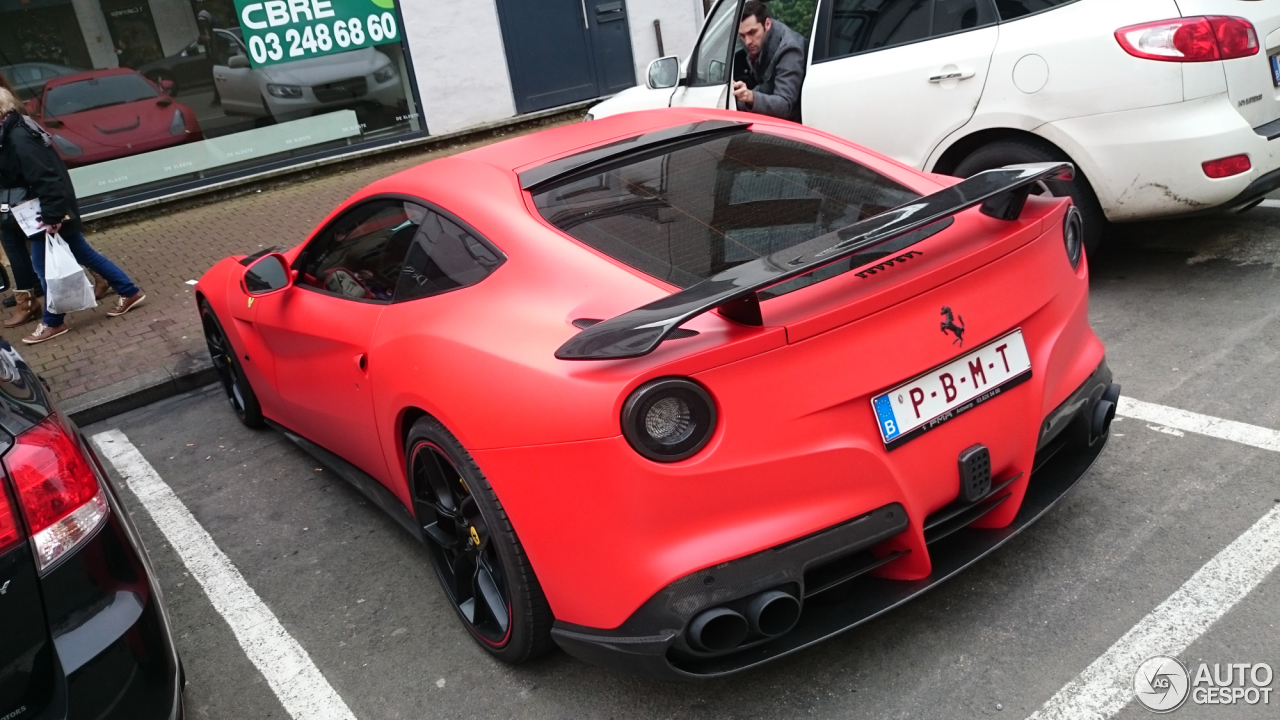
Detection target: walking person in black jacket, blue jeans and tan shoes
<box><xmin>0</xmin><ymin>90</ymin><xmax>147</xmax><ymax>345</ymax></box>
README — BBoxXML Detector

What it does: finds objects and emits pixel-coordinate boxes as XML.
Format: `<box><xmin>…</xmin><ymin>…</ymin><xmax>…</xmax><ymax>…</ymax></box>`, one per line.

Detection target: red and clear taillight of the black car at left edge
<box><xmin>5</xmin><ymin>416</ymin><xmax>108</xmax><ymax>571</ymax></box>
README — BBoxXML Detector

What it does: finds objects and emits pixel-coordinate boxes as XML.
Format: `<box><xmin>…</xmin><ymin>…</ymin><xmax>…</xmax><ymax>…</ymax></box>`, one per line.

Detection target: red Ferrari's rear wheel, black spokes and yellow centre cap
<box><xmin>404</xmin><ymin>418</ymin><xmax>553</xmax><ymax>664</ymax></box>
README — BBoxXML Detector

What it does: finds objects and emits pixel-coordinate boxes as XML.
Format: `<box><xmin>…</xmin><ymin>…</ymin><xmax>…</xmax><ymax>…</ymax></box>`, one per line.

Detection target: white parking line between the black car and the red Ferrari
<box><xmin>93</xmin><ymin>430</ymin><xmax>356</xmax><ymax>720</ymax></box>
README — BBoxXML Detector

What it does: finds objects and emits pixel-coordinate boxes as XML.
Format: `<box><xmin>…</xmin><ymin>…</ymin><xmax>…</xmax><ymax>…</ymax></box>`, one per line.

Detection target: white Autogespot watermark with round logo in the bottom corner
<box><xmin>1133</xmin><ymin>655</ymin><xmax>1275</xmax><ymax>712</ymax></box>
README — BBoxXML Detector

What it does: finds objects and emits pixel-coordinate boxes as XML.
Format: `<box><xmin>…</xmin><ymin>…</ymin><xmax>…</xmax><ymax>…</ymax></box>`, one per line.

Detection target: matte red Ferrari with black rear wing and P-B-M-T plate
<box><xmin>197</xmin><ymin>109</ymin><xmax>1120</xmax><ymax>676</ymax></box>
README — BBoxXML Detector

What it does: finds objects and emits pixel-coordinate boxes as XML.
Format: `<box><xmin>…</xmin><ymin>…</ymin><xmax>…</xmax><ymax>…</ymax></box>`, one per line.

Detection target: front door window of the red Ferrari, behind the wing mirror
<box><xmin>298</xmin><ymin>200</ymin><xmax>428</xmax><ymax>302</ymax></box>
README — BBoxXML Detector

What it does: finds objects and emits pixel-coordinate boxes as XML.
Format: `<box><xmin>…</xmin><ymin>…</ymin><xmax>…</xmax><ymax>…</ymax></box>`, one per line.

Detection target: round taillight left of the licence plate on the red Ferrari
<box><xmin>622</xmin><ymin>378</ymin><xmax>716</xmax><ymax>462</ymax></box>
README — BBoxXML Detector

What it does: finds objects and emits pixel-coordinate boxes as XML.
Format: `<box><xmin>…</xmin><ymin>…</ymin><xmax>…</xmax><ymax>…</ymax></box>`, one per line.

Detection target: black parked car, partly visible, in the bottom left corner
<box><xmin>0</xmin><ymin>341</ymin><xmax>183</xmax><ymax>720</ymax></box>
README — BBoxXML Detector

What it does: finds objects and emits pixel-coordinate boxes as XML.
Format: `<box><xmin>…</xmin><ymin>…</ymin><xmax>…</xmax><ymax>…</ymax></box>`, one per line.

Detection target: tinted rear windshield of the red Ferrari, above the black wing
<box><xmin>534</xmin><ymin>132</ymin><xmax>920</xmax><ymax>296</ymax></box>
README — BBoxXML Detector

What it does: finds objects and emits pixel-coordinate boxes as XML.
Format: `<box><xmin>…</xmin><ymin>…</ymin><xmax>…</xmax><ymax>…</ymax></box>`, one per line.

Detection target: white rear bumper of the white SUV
<box><xmin>1036</xmin><ymin>92</ymin><xmax>1280</xmax><ymax>222</ymax></box>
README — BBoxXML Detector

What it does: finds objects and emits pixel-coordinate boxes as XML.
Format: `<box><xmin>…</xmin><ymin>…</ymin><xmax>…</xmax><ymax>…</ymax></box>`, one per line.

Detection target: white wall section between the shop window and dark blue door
<box><xmin>399</xmin><ymin>0</ymin><xmax>516</xmax><ymax>135</ymax></box>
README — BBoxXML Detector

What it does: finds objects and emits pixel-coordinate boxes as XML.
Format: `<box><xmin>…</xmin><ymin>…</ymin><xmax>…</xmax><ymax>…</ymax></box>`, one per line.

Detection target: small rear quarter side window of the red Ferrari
<box><xmin>396</xmin><ymin>210</ymin><xmax>506</xmax><ymax>302</ymax></box>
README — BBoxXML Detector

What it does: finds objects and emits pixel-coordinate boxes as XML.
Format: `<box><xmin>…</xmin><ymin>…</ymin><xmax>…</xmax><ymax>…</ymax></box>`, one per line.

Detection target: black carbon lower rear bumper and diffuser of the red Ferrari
<box><xmin>552</xmin><ymin>361</ymin><xmax>1119</xmax><ymax>678</ymax></box>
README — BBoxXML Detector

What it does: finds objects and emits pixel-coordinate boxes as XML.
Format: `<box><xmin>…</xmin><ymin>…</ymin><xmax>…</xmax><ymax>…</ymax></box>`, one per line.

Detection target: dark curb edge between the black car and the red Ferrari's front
<box><xmin>59</xmin><ymin>356</ymin><xmax>218</xmax><ymax>428</ymax></box>
